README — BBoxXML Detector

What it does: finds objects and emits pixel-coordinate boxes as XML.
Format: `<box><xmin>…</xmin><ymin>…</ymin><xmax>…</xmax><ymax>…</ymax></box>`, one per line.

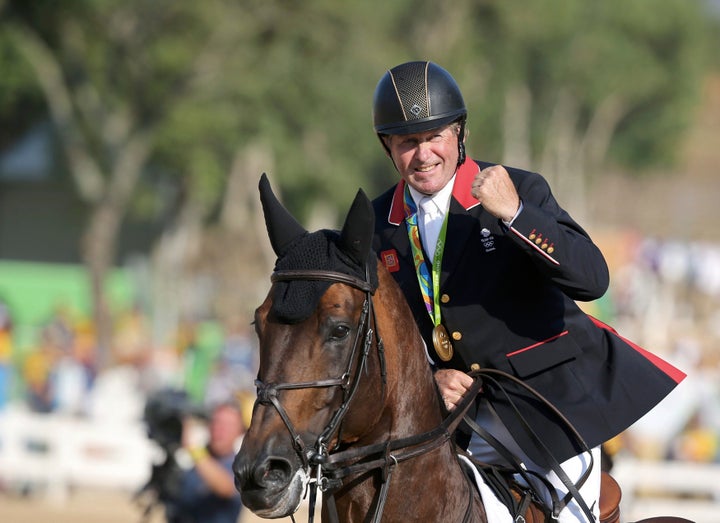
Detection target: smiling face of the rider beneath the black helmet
<box><xmin>385</xmin><ymin>124</ymin><xmax>459</xmax><ymax>194</ymax></box>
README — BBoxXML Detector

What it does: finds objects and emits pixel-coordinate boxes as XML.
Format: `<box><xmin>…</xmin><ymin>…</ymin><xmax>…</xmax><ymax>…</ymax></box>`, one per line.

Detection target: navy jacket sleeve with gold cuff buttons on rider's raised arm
<box><xmin>508</xmin><ymin>170</ymin><xmax>610</xmax><ymax>301</ymax></box>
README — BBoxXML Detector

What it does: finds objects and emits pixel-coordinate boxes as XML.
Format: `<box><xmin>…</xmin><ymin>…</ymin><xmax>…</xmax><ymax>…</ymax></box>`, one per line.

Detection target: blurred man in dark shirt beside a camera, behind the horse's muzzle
<box><xmin>166</xmin><ymin>403</ymin><xmax>245</xmax><ymax>523</ymax></box>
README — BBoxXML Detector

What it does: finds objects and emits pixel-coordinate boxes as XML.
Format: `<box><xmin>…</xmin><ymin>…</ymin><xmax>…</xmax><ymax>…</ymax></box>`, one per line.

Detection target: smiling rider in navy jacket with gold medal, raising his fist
<box><xmin>373</xmin><ymin>62</ymin><xmax>685</xmax><ymax>521</ymax></box>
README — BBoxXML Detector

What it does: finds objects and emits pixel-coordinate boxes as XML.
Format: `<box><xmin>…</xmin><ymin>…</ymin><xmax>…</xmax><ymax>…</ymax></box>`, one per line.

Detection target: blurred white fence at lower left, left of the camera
<box><xmin>0</xmin><ymin>407</ymin><xmax>158</xmax><ymax>500</ymax></box>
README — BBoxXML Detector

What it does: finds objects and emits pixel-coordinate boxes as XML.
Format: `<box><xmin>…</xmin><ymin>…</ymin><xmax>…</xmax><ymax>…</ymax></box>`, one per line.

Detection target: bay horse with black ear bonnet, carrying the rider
<box><xmin>233</xmin><ymin>174</ymin><xmax>688</xmax><ymax>523</ymax></box>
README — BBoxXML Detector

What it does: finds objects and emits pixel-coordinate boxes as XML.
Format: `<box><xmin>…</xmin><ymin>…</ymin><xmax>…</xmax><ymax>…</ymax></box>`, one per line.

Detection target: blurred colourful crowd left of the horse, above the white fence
<box><xmin>0</xmin><ymin>303</ymin><xmax>257</xmax><ymax>426</ymax></box>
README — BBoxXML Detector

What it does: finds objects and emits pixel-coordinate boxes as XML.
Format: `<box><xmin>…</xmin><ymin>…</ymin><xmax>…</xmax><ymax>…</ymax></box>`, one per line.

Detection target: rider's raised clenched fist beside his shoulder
<box><xmin>470</xmin><ymin>165</ymin><xmax>520</xmax><ymax>222</ymax></box>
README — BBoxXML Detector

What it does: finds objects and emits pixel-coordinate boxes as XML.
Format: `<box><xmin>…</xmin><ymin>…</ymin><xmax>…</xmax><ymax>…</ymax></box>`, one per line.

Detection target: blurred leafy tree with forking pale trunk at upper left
<box><xmin>3</xmin><ymin>1</ymin><xmax>253</xmax><ymax>366</ymax></box>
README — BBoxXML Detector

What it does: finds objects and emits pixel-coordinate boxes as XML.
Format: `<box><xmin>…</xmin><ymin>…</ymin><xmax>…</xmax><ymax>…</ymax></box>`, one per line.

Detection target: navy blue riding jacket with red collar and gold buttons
<box><xmin>373</xmin><ymin>159</ymin><xmax>685</xmax><ymax>465</ymax></box>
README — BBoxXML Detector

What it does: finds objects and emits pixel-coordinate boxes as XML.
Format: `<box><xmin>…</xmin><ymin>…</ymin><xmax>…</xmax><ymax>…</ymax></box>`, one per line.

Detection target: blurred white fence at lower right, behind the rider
<box><xmin>612</xmin><ymin>458</ymin><xmax>720</xmax><ymax>523</ymax></box>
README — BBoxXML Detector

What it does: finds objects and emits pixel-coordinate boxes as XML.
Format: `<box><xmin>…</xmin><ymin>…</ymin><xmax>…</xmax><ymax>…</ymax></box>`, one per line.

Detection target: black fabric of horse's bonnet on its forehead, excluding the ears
<box><xmin>271</xmin><ymin>229</ymin><xmax>377</xmax><ymax>324</ymax></box>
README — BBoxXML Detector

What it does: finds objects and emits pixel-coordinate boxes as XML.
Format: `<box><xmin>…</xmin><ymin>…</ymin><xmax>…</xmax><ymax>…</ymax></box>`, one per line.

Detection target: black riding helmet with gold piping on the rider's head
<box><xmin>373</xmin><ymin>61</ymin><xmax>467</xmax><ymax>165</ymax></box>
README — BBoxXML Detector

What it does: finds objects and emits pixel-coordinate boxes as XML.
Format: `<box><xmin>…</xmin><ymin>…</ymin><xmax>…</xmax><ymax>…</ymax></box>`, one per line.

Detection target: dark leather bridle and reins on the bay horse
<box><xmin>255</xmin><ymin>270</ymin><xmax>481</xmax><ymax>523</ymax></box>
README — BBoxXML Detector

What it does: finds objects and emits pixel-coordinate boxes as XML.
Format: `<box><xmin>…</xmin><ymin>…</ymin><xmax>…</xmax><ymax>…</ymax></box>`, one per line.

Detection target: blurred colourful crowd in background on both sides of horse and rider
<box><xmin>0</xmin><ymin>234</ymin><xmax>720</xmax><ymax>462</ymax></box>
